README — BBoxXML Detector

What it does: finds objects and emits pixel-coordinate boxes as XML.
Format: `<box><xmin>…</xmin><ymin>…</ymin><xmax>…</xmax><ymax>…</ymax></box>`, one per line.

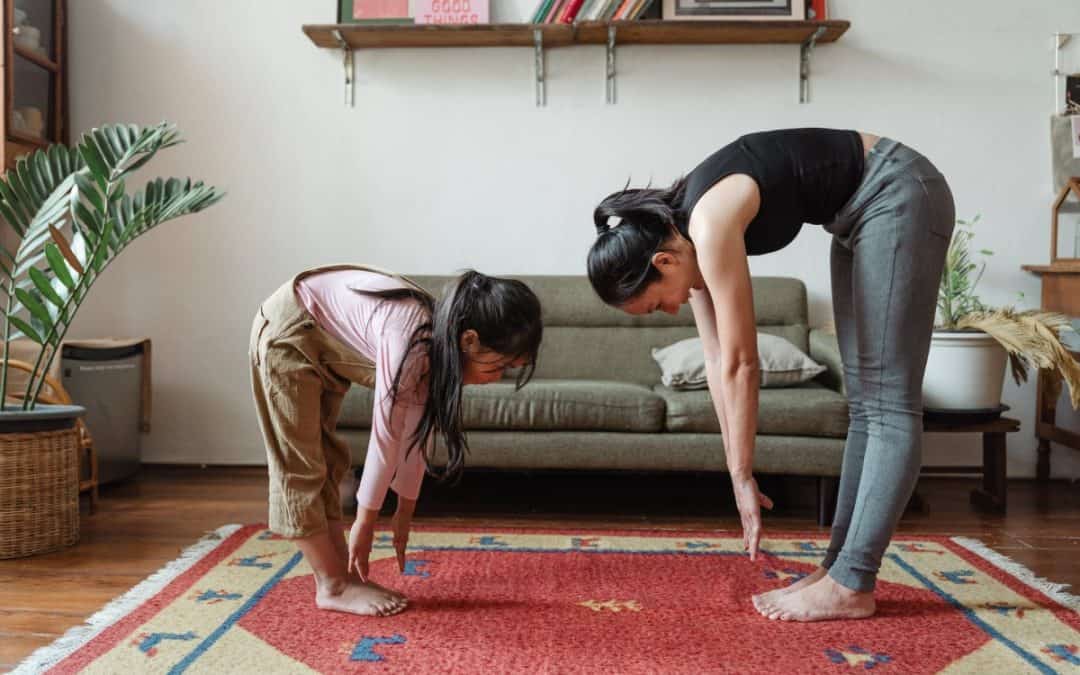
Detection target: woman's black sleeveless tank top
<box><xmin>680</xmin><ymin>129</ymin><xmax>864</xmax><ymax>255</ymax></box>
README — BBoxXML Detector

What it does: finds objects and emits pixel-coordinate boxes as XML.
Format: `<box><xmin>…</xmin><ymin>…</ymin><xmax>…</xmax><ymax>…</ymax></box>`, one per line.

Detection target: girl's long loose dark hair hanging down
<box><xmin>358</xmin><ymin>270</ymin><xmax>543</xmax><ymax>481</ymax></box>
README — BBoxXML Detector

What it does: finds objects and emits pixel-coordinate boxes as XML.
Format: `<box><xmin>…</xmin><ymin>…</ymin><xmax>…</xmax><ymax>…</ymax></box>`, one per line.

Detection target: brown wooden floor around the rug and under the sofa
<box><xmin>0</xmin><ymin>467</ymin><xmax>1080</xmax><ymax>671</ymax></box>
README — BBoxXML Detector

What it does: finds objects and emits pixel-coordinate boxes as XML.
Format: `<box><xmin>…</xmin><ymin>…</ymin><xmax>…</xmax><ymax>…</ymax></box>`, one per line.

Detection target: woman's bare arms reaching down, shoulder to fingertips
<box><xmin>690</xmin><ymin>176</ymin><xmax>771</xmax><ymax>558</ymax></box>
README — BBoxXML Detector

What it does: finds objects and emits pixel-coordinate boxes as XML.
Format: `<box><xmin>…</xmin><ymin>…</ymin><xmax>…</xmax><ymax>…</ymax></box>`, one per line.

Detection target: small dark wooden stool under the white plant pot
<box><xmin>921</xmin><ymin>413</ymin><xmax>1020</xmax><ymax>514</ymax></box>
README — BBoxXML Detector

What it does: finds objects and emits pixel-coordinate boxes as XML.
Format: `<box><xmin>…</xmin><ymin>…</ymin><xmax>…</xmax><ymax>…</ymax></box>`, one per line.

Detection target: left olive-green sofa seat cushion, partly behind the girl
<box><xmin>338</xmin><ymin>380</ymin><xmax>664</xmax><ymax>432</ymax></box>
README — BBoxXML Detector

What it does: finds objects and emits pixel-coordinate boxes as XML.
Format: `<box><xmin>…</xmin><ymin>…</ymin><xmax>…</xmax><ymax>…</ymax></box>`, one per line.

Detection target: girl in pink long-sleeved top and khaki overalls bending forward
<box><xmin>249</xmin><ymin>266</ymin><xmax>542</xmax><ymax>616</ymax></box>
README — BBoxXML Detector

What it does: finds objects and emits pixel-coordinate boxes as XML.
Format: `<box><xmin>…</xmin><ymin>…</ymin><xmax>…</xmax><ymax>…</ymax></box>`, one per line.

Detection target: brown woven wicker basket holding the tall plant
<box><xmin>0</xmin><ymin>428</ymin><xmax>79</xmax><ymax>558</ymax></box>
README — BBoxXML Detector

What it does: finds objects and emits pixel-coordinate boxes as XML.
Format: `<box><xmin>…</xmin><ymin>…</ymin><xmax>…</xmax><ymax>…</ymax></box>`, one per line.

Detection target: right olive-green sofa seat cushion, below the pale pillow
<box><xmin>654</xmin><ymin>382</ymin><xmax>848</xmax><ymax>438</ymax></box>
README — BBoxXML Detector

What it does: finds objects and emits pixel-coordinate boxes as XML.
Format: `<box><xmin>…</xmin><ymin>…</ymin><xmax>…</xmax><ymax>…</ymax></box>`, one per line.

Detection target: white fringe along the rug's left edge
<box><xmin>12</xmin><ymin>525</ymin><xmax>242</xmax><ymax>675</ymax></box>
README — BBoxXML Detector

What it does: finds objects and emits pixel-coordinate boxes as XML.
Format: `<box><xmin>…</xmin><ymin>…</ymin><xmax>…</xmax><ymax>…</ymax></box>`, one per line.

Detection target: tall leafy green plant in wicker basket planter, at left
<box><xmin>0</xmin><ymin>122</ymin><xmax>222</xmax><ymax>558</ymax></box>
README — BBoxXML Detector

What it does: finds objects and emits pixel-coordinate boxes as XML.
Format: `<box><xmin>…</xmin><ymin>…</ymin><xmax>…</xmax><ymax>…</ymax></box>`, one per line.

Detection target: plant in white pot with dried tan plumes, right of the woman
<box><xmin>922</xmin><ymin>216</ymin><xmax>1080</xmax><ymax>415</ymax></box>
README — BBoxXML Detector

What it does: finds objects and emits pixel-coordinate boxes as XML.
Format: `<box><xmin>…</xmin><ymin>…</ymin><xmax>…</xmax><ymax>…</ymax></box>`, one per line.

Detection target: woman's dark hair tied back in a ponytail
<box><xmin>588</xmin><ymin>178</ymin><xmax>687</xmax><ymax>307</ymax></box>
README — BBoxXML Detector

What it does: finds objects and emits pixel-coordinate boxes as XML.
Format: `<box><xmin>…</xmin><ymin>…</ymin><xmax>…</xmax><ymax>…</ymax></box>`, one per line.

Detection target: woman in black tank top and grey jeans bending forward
<box><xmin>589</xmin><ymin>129</ymin><xmax>955</xmax><ymax>621</ymax></box>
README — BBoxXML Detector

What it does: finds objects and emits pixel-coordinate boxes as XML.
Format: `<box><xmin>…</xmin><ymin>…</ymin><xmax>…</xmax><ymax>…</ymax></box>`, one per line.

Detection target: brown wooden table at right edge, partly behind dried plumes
<box><xmin>1024</xmin><ymin>262</ymin><xmax>1080</xmax><ymax>481</ymax></box>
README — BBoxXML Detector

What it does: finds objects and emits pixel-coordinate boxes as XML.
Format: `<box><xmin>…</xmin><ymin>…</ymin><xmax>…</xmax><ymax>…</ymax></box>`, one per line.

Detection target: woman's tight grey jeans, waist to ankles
<box><xmin>823</xmin><ymin>138</ymin><xmax>955</xmax><ymax>591</ymax></box>
